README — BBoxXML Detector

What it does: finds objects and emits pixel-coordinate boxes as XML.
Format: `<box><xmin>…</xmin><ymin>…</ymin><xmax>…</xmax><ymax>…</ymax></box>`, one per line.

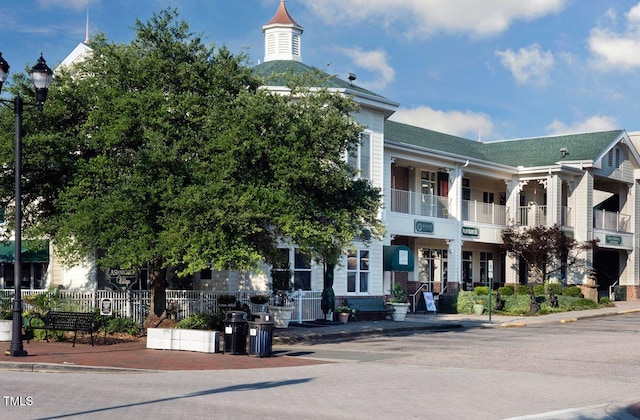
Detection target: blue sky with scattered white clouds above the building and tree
<box><xmin>0</xmin><ymin>0</ymin><xmax>640</xmax><ymax>141</ymax></box>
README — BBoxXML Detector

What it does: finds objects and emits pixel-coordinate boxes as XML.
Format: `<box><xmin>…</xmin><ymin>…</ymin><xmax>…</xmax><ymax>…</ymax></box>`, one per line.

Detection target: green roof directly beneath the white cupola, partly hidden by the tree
<box><xmin>253</xmin><ymin>60</ymin><xmax>383</xmax><ymax>98</ymax></box>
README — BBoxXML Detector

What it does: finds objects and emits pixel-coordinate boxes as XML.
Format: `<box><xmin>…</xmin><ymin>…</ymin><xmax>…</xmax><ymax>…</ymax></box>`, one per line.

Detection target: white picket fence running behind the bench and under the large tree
<box><xmin>0</xmin><ymin>289</ymin><xmax>324</xmax><ymax>323</ymax></box>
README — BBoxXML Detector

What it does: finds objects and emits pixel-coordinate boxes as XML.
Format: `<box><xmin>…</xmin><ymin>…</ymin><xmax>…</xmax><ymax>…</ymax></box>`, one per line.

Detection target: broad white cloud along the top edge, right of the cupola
<box><xmin>305</xmin><ymin>0</ymin><xmax>569</xmax><ymax>37</ymax></box>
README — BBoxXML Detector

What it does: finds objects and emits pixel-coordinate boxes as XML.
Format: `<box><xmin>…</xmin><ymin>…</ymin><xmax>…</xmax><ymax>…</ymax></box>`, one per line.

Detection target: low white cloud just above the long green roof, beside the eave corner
<box><xmin>390</xmin><ymin>106</ymin><xmax>494</xmax><ymax>140</ymax></box>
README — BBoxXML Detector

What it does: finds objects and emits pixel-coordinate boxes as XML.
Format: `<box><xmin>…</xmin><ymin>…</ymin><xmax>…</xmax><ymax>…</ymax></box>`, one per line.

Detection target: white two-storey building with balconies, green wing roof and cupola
<box><xmin>11</xmin><ymin>1</ymin><xmax>640</xmax><ymax>300</ymax></box>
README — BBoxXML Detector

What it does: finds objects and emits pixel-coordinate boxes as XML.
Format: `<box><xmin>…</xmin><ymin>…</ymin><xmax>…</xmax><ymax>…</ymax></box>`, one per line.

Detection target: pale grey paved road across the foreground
<box><xmin>0</xmin><ymin>314</ymin><xmax>640</xmax><ymax>420</ymax></box>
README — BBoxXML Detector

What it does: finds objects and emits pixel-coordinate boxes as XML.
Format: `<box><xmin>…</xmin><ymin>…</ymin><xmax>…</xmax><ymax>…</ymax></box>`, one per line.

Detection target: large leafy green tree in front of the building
<box><xmin>0</xmin><ymin>9</ymin><xmax>381</xmax><ymax>315</ymax></box>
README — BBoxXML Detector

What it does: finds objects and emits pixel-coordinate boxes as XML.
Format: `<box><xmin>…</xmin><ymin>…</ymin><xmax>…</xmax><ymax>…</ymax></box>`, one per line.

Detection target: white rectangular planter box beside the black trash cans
<box><xmin>147</xmin><ymin>328</ymin><xmax>220</xmax><ymax>353</ymax></box>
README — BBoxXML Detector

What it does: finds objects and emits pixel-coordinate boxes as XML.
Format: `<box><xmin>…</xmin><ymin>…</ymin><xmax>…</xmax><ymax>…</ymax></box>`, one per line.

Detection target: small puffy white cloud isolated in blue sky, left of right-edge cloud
<box><xmin>496</xmin><ymin>44</ymin><xmax>554</xmax><ymax>85</ymax></box>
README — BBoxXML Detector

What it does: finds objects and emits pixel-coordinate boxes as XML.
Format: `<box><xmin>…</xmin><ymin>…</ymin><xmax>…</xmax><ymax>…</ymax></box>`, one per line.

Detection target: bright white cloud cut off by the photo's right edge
<box><xmin>588</xmin><ymin>4</ymin><xmax>640</xmax><ymax>70</ymax></box>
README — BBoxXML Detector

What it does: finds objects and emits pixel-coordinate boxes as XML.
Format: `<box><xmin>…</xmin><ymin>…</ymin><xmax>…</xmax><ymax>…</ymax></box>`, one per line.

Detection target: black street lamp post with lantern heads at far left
<box><xmin>0</xmin><ymin>53</ymin><xmax>53</xmax><ymax>357</ymax></box>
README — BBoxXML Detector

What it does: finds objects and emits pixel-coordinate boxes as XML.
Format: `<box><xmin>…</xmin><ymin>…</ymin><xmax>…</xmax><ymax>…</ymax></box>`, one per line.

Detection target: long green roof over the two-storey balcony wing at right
<box><xmin>384</xmin><ymin>120</ymin><xmax>624</xmax><ymax>167</ymax></box>
